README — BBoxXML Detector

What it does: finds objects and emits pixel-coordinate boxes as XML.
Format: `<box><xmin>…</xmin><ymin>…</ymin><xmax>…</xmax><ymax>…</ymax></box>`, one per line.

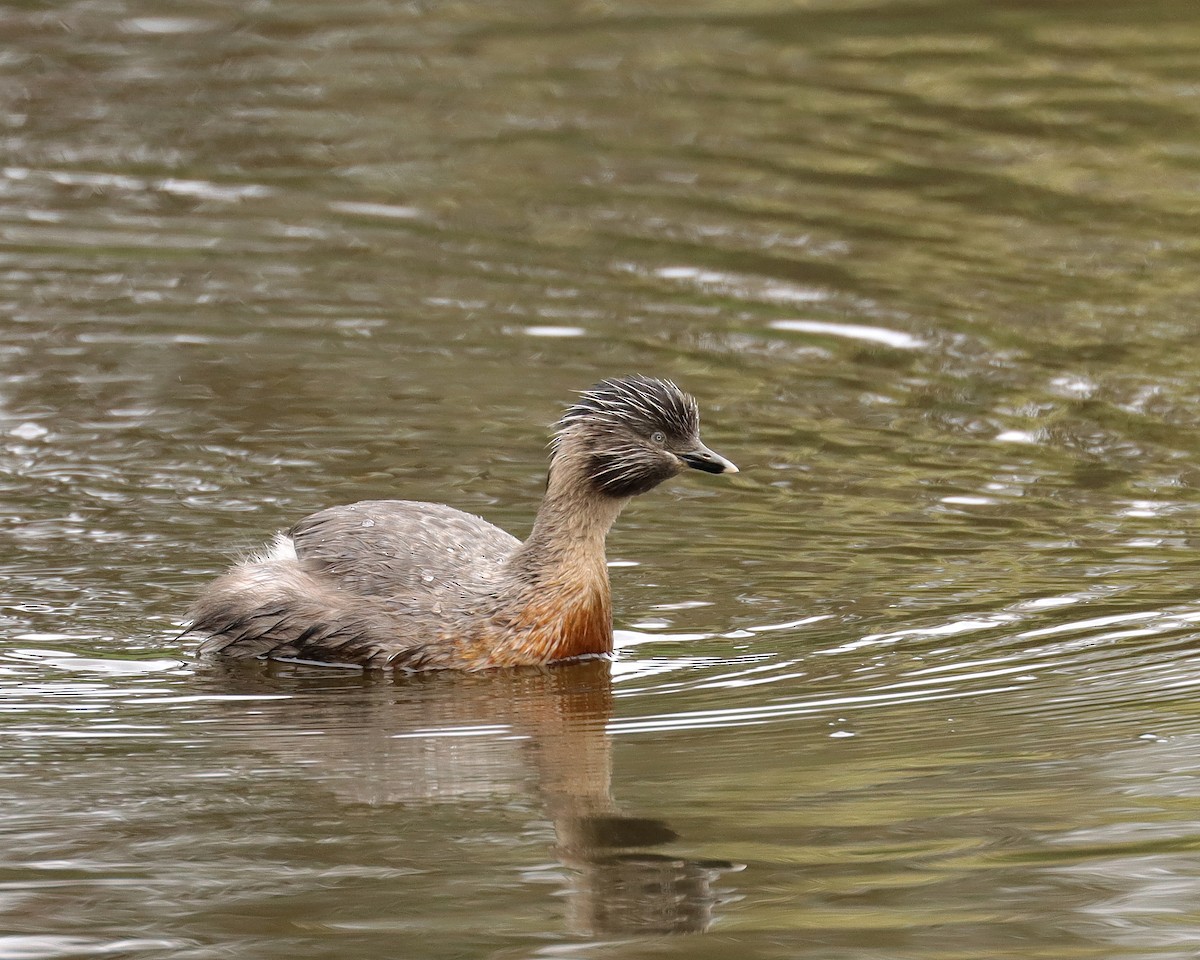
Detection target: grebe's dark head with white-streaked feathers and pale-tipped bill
<box><xmin>553</xmin><ymin>376</ymin><xmax>738</xmax><ymax>498</ymax></box>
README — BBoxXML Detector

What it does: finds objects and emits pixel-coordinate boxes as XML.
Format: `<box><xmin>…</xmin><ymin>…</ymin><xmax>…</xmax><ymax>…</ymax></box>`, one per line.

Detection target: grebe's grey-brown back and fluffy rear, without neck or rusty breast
<box><xmin>188</xmin><ymin>500</ymin><xmax>520</xmax><ymax>668</ymax></box>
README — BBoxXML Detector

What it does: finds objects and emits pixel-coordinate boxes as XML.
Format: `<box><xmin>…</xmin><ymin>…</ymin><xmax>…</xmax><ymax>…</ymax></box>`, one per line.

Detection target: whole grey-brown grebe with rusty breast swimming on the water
<box><xmin>188</xmin><ymin>377</ymin><xmax>737</xmax><ymax>670</ymax></box>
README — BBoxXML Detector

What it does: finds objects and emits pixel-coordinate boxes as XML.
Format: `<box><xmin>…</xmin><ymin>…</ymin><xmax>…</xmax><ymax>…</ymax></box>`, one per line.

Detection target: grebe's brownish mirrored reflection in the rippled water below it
<box><xmin>211</xmin><ymin>660</ymin><xmax>742</xmax><ymax>935</ymax></box>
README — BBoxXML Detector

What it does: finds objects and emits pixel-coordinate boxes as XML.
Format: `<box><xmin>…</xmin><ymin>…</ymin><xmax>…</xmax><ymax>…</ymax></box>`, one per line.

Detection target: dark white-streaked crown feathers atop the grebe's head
<box><xmin>554</xmin><ymin>374</ymin><xmax>700</xmax><ymax>442</ymax></box>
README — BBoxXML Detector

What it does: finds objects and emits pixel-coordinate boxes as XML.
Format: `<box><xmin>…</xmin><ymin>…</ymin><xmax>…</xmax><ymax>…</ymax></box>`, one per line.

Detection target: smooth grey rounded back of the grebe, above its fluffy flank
<box><xmin>287</xmin><ymin>500</ymin><xmax>520</xmax><ymax>604</ymax></box>
